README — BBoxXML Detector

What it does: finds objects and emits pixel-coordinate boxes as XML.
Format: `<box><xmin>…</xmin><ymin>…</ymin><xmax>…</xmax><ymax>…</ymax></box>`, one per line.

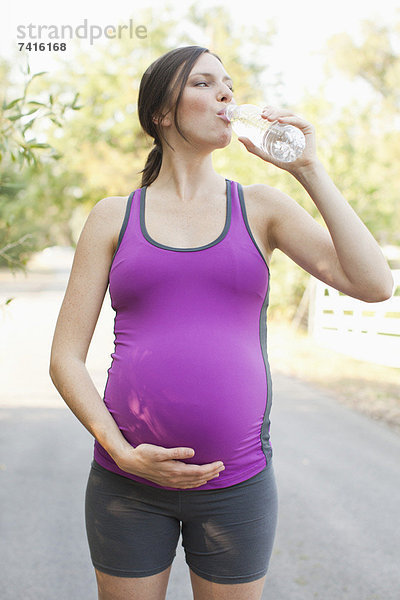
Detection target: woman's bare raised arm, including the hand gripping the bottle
<box><xmin>241</xmin><ymin>109</ymin><xmax>393</xmax><ymax>302</ymax></box>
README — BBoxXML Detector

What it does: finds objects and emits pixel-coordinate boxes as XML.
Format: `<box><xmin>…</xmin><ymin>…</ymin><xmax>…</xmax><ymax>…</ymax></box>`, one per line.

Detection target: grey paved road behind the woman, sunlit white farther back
<box><xmin>0</xmin><ymin>264</ymin><xmax>400</xmax><ymax>600</ymax></box>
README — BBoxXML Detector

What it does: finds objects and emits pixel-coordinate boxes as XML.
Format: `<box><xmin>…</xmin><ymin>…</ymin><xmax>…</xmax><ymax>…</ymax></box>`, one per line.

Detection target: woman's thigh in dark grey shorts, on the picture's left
<box><xmin>85</xmin><ymin>463</ymin><xmax>180</xmax><ymax>586</ymax></box>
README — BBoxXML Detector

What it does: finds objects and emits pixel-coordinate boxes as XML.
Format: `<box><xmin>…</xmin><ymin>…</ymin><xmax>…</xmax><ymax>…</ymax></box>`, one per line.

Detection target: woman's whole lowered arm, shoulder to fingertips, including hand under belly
<box><xmin>49</xmin><ymin>198</ymin><xmax>225</xmax><ymax>488</ymax></box>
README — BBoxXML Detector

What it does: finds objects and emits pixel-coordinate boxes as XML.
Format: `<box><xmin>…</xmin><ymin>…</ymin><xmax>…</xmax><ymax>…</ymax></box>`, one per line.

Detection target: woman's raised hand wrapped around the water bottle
<box><xmin>238</xmin><ymin>106</ymin><xmax>318</xmax><ymax>173</ymax></box>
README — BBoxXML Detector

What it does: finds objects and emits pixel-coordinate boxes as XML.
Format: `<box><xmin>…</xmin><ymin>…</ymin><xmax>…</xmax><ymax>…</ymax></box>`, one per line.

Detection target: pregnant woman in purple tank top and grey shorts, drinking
<box><xmin>50</xmin><ymin>46</ymin><xmax>393</xmax><ymax>600</ymax></box>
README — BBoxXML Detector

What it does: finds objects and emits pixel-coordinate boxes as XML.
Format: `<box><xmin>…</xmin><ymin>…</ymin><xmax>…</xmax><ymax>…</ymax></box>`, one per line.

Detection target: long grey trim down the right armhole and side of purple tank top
<box><xmin>238</xmin><ymin>183</ymin><xmax>272</xmax><ymax>463</ymax></box>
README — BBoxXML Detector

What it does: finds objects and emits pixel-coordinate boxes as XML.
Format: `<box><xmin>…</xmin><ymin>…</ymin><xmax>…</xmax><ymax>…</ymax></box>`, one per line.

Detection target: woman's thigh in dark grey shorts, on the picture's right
<box><xmin>181</xmin><ymin>462</ymin><xmax>278</xmax><ymax>598</ymax></box>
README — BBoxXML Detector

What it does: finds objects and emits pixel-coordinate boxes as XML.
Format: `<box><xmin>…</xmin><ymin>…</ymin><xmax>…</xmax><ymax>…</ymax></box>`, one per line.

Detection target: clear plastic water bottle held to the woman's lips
<box><xmin>225</xmin><ymin>103</ymin><xmax>306</xmax><ymax>162</ymax></box>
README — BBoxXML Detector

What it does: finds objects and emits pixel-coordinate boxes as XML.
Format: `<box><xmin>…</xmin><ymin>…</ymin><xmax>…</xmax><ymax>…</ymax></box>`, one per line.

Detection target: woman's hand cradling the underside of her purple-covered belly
<box><xmin>116</xmin><ymin>444</ymin><xmax>225</xmax><ymax>489</ymax></box>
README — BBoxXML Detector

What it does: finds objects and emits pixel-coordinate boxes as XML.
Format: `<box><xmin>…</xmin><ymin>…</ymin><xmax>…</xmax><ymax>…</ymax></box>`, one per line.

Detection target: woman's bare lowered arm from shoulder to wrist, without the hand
<box><xmin>49</xmin><ymin>198</ymin><xmax>132</xmax><ymax>456</ymax></box>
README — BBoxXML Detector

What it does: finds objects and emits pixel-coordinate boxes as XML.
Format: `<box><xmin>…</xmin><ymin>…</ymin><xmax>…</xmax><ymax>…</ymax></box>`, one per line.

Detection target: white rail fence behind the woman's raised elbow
<box><xmin>308</xmin><ymin>269</ymin><xmax>400</xmax><ymax>368</ymax></box>
